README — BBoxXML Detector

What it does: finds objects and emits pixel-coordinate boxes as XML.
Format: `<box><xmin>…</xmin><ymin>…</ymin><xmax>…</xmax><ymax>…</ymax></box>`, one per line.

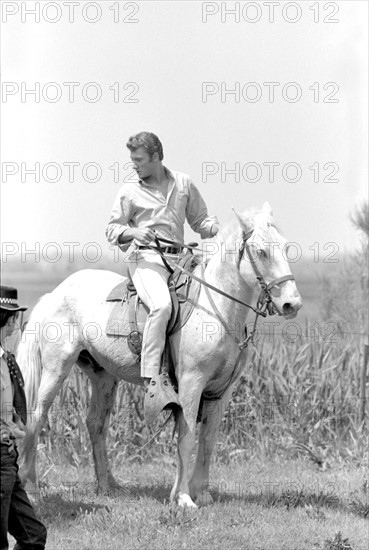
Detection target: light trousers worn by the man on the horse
<box><xmin>128</xmin><ymin>250</ymin><xmax>172</xmax><ymax>378</ymax></box>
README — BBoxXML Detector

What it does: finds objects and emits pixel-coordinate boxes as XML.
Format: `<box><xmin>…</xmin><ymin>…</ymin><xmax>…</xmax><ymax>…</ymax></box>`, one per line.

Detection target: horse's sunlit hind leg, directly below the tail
<box><xmin>20</xmin><ymin>343</ymin><xmax>78</xmax><ymax>496</ymax></box>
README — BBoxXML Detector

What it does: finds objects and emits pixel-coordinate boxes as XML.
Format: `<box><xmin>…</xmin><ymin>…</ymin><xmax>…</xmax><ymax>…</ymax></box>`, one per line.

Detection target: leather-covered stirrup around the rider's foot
<box><xmin>145</xmin><ymin>373</ymin><xmax>180</xmax><ymax>425</ymax></box>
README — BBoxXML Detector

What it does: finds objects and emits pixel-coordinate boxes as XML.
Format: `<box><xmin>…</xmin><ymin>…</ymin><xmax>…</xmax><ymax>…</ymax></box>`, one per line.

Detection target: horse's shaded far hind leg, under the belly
<box><xmin>81</xmin><ymin>366</ymin><xmax>121</xmax><ymax>494</ymax></box>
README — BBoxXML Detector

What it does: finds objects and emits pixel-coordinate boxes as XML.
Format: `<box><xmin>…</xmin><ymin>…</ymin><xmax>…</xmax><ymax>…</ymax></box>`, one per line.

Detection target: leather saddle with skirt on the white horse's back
<box><xmin>106</xmin><ymin>252</ymin><xmax>202</xmax><ymax>363</ymax></box>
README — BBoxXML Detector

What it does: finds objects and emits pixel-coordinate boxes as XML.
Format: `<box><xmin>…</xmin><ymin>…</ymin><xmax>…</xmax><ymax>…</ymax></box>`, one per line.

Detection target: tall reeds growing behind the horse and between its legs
<box><xmin>38</xmin><ymin>328</ymin><xmax>366</xmax><ymax>465</ymax></box>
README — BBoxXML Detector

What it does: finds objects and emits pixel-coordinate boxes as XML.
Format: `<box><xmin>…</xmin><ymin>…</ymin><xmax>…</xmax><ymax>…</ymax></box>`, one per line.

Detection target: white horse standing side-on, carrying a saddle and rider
<box><xmin>17</xmin><ymin>203</ymin><xmax>302</xmax><ymax>507</ymax></box>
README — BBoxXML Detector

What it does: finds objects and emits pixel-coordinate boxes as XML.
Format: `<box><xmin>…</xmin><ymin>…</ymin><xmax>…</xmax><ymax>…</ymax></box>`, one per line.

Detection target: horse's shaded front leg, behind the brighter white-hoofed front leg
<box><xmin>189</xmin><ymin>389</ymin><xmax>231</xmax><ymax>505</ymax></box>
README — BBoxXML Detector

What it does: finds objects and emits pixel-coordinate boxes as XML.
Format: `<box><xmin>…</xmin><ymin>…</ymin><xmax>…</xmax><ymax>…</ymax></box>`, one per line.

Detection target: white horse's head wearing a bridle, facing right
<box><xmin>235</xmin><ymin>203</ymin><xmax>302</xmax><ymax>319</ymax></box>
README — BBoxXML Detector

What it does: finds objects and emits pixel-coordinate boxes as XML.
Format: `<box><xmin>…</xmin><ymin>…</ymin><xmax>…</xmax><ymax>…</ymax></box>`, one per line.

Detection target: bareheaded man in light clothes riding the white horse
<box><xmin>106</xmin><ymin>132</ymin><xmax>219</xmax><ymax>418</ymax></box>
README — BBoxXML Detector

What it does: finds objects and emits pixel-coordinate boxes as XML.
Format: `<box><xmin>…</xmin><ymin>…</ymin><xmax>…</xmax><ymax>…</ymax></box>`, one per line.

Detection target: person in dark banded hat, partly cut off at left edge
<box><xmin>0</xmin><ymin>286</ymin><xmax>46</xmax><ymax>550</ymax></box>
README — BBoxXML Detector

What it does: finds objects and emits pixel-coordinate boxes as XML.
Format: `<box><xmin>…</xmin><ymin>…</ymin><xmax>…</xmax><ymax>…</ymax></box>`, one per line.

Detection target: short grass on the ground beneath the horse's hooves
<box><xmin>10</xmin><ymin>457</ymin><xmax>369</xmax><ymax>550</ymax></box>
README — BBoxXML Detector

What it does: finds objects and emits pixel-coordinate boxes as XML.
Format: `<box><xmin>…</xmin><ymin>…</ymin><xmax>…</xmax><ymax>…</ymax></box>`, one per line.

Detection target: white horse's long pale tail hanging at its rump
<box><xmin>17</xmin><ymin>294</ymin><xmax>50</xmax><ymax>416</ymax></box>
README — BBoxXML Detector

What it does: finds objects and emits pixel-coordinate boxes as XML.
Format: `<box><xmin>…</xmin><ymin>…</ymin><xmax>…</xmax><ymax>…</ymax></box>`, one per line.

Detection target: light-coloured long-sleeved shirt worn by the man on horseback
<box><xmin>105</xmin><ymin>168</ymin><xmax>219</xmax><ymax>250</ymax></box>
